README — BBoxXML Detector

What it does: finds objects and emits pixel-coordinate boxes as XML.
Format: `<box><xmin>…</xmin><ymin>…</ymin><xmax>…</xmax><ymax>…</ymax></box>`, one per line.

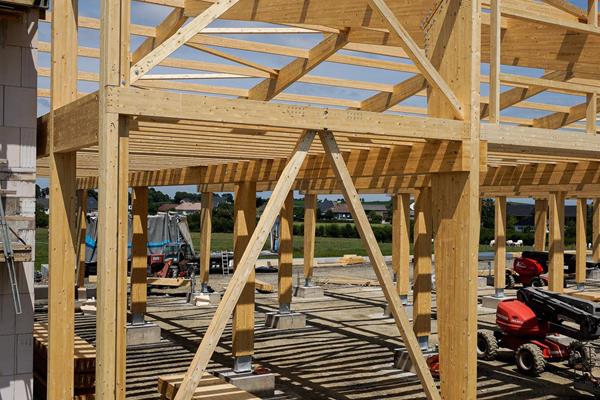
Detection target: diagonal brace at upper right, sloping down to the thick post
<box><xmin>369</xmin><ymin>0</ymin><xmax>464</xmax><ymax>120</ymax></box>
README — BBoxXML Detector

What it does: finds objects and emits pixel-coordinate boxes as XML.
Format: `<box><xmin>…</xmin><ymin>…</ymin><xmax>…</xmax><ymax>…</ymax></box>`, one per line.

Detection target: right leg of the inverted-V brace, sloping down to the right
<box><xmin>319</xmin><ymin>131</ymin><xmax>440</xmax><ymax>399</ymax></box>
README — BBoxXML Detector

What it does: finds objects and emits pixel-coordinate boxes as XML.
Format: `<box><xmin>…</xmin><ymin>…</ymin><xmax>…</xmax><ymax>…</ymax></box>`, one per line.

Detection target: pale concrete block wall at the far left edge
<box><xmin>0</xmin><ymin>10</ymin><xmax>38</xmax><ymax>400</ymax></box>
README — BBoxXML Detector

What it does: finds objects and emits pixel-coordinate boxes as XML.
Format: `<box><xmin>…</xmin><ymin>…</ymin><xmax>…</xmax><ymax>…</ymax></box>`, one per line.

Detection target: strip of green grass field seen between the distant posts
<box><xmin>35</xmin><ymin>228</ymin><xmax>530</xmax><ymax>269</ymax></box>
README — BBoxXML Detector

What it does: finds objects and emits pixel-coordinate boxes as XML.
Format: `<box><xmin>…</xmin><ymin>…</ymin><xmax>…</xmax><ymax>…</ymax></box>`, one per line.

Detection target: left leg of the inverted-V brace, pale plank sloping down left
<box><xmin>175</xmin><ymin>131</ymin><xmax>315</xmax><ymax>400</ymax></box>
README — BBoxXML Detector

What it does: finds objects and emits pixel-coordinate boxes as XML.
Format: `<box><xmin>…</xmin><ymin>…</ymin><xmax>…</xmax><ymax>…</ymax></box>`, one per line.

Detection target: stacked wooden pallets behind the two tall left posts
<box><xmin>33</xmin><ymin>323</ymin><xmax>96</xmax><ymax>400</ymax></box>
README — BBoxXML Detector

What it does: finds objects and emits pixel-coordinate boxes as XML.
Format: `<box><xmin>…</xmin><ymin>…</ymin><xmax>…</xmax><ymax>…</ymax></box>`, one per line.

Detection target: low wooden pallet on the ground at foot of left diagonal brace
<box><xmin>158</xmin><ymin>372</ymin><xmax>259</xmax><ymax>400</ymax></box>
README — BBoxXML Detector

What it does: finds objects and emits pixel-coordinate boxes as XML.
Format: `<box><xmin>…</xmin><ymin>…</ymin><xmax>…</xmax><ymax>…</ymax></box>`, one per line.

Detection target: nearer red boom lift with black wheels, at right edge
<box><xmin>477</xmin><ymin>287</ymin><xmax>600</xmax><ymax>394</ymax></box>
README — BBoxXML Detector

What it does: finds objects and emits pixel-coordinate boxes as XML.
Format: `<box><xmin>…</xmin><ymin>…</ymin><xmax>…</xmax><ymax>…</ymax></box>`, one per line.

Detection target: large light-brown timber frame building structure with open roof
<box><xmin>38</xmin><ymin>0</ymin><xmax>600</xmax><ymax>400</ymax></box>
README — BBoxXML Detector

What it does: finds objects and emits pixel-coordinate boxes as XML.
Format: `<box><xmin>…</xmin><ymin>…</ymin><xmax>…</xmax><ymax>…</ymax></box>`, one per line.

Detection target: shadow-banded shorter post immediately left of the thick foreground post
<box><xmin>413</xmin><ymin>188</ymin><xmax>433</xmax><ymax>349</ymax></box>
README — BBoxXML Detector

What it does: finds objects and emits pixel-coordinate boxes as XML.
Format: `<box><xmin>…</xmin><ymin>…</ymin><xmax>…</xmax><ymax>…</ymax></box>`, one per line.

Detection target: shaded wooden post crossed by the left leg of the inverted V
<box><xmin>232</xmin><ymin>182</ymin><xmax>256</xmax><ymax>372</ymax></box>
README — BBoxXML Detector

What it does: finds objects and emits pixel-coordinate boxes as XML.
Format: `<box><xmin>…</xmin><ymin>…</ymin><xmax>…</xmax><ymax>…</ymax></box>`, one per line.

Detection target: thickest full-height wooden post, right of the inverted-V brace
<box><xmin>425</xmin><ymin>0</ymin><xmax>481</xmax><ymax>400</ymax></box>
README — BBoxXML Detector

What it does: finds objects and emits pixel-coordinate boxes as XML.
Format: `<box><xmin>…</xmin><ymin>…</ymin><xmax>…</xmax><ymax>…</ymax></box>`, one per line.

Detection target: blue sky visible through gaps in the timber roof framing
<box><xmin>38</xmin><ymin>0</ymin><xmax>587</xmax><ymax>203</ymax></box>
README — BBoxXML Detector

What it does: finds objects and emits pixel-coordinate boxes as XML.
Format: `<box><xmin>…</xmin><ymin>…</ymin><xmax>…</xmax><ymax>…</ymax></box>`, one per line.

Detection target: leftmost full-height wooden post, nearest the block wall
<box><xmin>46</xmin><ymin>0</ymin><xmax>79</xmax><ymax>400</ymax></box>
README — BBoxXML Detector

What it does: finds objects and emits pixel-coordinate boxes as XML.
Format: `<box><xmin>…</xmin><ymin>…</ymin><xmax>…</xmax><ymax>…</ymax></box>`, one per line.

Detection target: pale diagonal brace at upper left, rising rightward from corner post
<box><xmin>129</xmin><ymin>0</ymin><xmax>239</xmax><ymax>84</ymax></box>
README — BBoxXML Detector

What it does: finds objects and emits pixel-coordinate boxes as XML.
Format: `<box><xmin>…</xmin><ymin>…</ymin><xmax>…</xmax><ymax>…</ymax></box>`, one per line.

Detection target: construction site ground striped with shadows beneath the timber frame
<box><xmin>36</xmin><ymin>263</ymin><xmax>593</xmax><ymax>400</ymax></box>
